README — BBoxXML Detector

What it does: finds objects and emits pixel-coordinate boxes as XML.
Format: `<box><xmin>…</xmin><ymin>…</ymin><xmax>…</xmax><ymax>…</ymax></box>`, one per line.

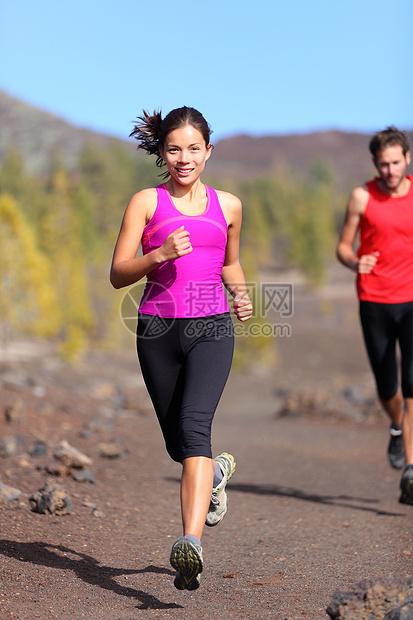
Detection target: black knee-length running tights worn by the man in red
<box><xmin>360</xmin><ymin>301</ymin><xmax>413</xmax><ymax>400</ymax></box>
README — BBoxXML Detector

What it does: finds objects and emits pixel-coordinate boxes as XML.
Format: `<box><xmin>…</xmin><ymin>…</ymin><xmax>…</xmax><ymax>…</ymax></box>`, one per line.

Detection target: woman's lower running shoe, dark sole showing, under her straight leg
<box><xmin>171</xmin><ymin>536</ymin><xmax>204</xmax><ymax>590</ymax></box>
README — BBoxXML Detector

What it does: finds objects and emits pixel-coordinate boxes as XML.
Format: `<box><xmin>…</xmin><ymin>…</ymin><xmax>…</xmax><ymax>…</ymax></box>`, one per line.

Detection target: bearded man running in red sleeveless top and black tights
<box><xmin>337</xmin><ymin>126</ymin><xmax>413</xmax><ymax>505</ymax></box>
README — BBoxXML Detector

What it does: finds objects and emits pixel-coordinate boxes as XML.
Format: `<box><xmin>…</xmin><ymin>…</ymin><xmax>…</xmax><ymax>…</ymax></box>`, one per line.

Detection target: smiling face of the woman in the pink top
<box><xmin>160</xmin><ymin>125</ymin><xmax>212</xmax><ymax>185</ymax></box>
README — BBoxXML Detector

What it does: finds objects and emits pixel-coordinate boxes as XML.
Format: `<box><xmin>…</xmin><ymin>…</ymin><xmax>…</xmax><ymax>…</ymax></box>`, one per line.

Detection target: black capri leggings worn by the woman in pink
<box><xmin>137</xmin><ymin>313</ymin><xmax>234</xmax><ymax>462</ymax></box>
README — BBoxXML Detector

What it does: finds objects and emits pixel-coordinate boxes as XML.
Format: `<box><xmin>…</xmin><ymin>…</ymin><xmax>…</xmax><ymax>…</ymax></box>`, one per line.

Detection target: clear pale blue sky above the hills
<box><xmin>0</xmin><ymin>0</ymin><xmax>413</xmax><ymax>140</ymax></box>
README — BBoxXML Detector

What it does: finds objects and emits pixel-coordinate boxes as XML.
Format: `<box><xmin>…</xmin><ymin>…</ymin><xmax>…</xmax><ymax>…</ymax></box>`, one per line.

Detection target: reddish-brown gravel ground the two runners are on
<box><xmin>0</xmin><ymin>268</ymin><xmax>413</xmax><ymax>620</ymax></box>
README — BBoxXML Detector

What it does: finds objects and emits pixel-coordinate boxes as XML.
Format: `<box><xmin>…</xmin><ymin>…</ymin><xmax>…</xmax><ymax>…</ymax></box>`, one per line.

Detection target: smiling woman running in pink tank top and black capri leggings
<box><xmin>110</xmin><ymin>107</ymin><xmax>252</xmax><ymax>590</ymax></box>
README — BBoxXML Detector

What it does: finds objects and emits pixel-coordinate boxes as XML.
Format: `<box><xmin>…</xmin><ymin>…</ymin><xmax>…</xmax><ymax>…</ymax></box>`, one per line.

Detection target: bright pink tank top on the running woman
<box><xmin>139</xmin><ymin>184</ymin><xmax>229</xmax><ymax>318</ymax></box>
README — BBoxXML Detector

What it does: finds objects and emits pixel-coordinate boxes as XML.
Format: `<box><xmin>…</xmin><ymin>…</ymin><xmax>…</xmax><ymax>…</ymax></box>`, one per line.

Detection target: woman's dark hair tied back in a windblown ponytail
<box><xmin>129</xmin><ymin>106</ymin><xmax>212</xmax><ymax>177</ymax></box>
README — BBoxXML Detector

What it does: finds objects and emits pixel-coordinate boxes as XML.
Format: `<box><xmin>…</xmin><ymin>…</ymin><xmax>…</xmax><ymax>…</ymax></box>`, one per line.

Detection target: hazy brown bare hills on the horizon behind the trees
<box><xmin>0</xmin><ymin>91</ymin><xmax>413</xmax><ymax>191</ymax></box>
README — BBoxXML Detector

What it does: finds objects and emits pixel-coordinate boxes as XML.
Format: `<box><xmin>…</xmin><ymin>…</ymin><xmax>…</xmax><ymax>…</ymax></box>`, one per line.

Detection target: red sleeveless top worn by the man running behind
<box><xmin>357</xmin><ymin>175</ymin><xmax>413</xmax><ymax>304</ymax></box>
